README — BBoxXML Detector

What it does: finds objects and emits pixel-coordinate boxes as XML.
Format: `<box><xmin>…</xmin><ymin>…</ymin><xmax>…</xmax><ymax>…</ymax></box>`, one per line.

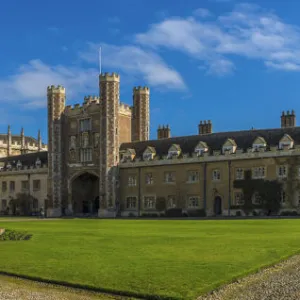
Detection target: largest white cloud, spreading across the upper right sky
<box><xmin>135</xmin><ymin>3</ymin><xmax>300</xmax><ymax>75</ymax></box>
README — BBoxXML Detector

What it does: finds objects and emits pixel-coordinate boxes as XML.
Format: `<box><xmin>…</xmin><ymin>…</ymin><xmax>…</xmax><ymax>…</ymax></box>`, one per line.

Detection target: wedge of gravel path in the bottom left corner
<box><xmin>0</xmin><ymin>276</ymin><xmax>135</xmax><ymax>300</ymax></box>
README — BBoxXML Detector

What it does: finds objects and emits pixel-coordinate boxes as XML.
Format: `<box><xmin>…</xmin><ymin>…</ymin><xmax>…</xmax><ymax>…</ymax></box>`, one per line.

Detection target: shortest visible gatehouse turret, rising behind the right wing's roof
<box><xmin>131</xmin><ymin>86</ymin><xmax>150</xmax><ymax>142</ymax></box>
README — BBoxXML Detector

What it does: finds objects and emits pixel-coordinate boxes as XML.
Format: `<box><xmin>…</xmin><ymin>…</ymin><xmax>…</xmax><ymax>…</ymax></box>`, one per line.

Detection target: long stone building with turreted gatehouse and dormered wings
<box><xmin>0</xmin><ymin>73</ymin><xmax>300</xmax><ymax>217</ymax></box>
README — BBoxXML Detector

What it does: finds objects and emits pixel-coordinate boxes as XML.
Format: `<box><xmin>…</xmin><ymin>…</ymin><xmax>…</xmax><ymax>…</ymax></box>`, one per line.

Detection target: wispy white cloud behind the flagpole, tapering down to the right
<box><xmin>80</xmin><ymin>43</ymin><xmax>185</xmax><ymax>89</ymax></box>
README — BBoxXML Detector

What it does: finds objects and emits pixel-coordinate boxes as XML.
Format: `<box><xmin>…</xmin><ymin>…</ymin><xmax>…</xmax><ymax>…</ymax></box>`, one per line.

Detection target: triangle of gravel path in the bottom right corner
<box><xmin>197</xmin><ymin>255</ymin><xmax>300</xmax><ymax>300</ymax></box>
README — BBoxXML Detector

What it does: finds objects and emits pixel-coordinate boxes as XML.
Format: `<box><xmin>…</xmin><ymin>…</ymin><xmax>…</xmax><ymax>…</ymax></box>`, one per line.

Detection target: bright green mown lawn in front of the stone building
<box><xmin>0</xmin><ymin>218</ymin><xmax>300</xmax><ymax>299</ymax></box>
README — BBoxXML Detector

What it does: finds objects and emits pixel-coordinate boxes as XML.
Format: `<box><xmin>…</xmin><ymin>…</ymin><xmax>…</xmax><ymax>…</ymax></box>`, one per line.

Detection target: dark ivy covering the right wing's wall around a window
<box><xmin>233</xmin><ymin>170</ymin><xmax>282</xmax><ymax>214</ymax></box>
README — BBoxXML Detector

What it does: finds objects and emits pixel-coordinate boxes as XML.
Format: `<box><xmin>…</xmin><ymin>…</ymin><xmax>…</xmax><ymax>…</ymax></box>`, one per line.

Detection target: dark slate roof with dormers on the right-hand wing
<box><xmin>120</xmin><ymin>127</ymin><xmax>300</xmax><ymax>157</ymax></box>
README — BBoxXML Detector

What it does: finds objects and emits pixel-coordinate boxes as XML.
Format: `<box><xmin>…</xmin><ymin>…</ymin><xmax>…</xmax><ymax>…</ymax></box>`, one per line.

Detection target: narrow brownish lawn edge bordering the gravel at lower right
<box><xmin>196</xmin><ymin>249</ymin><xmax>300</xmax><ymax>299</ymax></box>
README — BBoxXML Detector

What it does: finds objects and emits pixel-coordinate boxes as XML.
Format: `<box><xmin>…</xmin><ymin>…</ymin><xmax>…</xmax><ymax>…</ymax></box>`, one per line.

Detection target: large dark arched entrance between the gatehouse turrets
<box><xmin>72</xmin><ymin>172</ymin><xmax>99</xmax><ymax>215</ymax></box>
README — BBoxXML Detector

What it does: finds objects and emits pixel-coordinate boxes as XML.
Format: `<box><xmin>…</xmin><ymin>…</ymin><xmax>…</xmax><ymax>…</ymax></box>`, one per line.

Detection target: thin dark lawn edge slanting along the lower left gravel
<box><xmin>0</xmin><ymin>270</ymin><xmax>179</xmax><ymax>300</ymax></box>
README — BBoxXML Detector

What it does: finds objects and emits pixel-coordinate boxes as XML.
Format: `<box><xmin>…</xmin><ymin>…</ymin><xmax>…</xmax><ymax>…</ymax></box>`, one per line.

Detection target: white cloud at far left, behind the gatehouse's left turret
<box><xmin>0</xmin><ymin>60</ymin><xmax>97</xmax><ymax>107</ymax></box>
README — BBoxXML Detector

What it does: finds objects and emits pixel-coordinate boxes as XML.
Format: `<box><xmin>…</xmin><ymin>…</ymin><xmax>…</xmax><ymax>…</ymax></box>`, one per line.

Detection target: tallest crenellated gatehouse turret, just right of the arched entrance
<box><xmin>98</xmin><ymin>73</ymin><xmax>120</xmax><ymax>217</ymax></box>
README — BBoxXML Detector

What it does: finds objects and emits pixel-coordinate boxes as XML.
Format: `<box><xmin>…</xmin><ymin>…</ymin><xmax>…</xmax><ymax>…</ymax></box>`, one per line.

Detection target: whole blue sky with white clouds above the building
<box><xmin>0</xmin><ymin>0</ymin><xmax>300</xmax><ymax>141</ymax></box>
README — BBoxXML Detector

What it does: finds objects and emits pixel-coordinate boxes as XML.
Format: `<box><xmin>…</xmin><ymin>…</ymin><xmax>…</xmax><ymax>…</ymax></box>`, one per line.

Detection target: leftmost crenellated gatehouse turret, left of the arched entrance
<box><xmin>47</xmin><ymin>85</ymin><xmax>66</xmax><ymax>217</ymax></box>
